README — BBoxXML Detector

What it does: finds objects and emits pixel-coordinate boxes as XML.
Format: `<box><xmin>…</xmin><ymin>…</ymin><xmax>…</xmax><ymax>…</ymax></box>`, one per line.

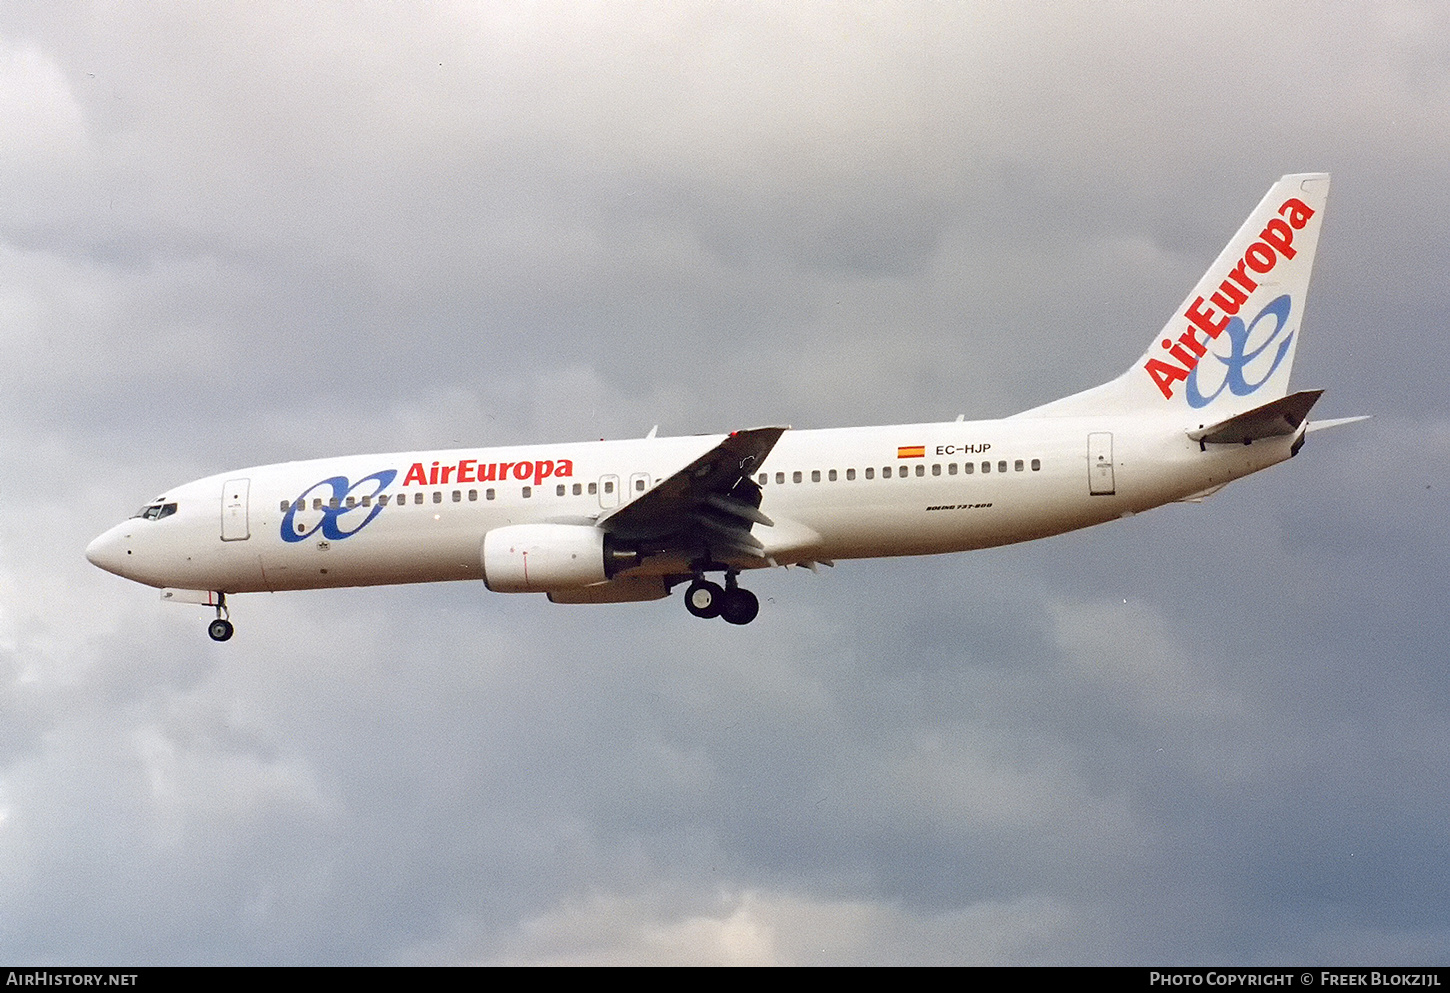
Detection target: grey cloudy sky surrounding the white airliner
<box><xmin>0</xmin><ymin>0</ymin><xmax>1450</xmax><ymax>964</ymax></box>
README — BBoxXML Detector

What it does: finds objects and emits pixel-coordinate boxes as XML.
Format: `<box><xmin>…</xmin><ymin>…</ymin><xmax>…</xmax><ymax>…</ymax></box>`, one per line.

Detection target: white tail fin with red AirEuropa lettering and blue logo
<box><xmin>1018</xmin><ymin>173</ymin><xmax>1330</xmax><ymax>420</ymax></box>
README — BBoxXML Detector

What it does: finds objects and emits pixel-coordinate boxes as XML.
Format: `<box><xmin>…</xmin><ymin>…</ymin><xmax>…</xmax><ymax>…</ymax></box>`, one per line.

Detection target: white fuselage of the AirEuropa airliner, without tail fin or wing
<box><xmin>87</xmin><ymin>415</ymin><xmax>1302</xmax><ymax>593</ymax></box>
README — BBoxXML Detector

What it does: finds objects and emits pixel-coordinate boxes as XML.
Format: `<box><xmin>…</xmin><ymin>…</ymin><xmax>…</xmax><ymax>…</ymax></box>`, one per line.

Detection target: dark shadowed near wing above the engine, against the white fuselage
<box><xmin>597</xmin><ymin>428</ymin><xmax>789</xmax><ymax>558</ymax></box>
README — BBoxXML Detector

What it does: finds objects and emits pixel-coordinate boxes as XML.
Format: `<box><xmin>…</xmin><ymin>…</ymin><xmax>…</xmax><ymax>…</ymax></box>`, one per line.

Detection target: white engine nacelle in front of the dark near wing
<box><xmin>480</xmin><ymin>525</ymin><xmax>609</xmax><ymax>593</ymax></box>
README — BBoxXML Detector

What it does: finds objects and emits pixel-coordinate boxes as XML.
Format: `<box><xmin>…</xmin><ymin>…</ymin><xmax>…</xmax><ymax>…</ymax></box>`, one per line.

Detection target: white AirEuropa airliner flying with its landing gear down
<box><xmin>86</xmin><ymin>174</ymin><xmax>1364</xmax><ymax>641</ymax></box>
